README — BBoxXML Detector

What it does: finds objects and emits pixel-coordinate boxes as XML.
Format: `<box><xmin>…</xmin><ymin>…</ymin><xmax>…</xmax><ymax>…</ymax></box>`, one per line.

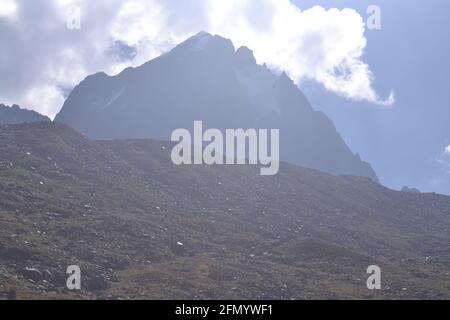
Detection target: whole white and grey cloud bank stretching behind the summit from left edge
<box><xmin>0</xmin><ymin>0</ymin><xmax>394</xmax><ymax>116</ymax></box>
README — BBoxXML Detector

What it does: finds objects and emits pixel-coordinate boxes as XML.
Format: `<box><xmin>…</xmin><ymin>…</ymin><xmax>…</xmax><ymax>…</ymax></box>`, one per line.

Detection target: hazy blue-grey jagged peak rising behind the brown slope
<box><xmin>55</xmin><ymin>32</ymin><xmax>378</xmax><ymax>181</ymax></box>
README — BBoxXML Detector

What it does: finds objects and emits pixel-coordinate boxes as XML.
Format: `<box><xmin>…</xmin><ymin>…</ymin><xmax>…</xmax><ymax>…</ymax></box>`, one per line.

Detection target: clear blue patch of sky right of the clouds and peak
<box><xmin>297</xmin><ymin>0</ymin><xmax>450</xmax><ymax>194</ymax></box>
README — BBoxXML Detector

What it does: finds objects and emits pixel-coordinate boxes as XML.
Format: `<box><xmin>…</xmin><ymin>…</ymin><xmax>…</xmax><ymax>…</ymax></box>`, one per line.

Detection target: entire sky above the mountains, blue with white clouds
<box><xmin>0</xmin><ymin>0</ymin><xmax>450</xmax><ymax>194</ymax></box>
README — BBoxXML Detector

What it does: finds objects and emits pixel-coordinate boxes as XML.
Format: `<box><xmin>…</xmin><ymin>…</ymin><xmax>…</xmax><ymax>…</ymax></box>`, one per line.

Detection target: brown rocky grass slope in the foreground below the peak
<box><xmin>0</xmin><ymin>122</ymin><xmax>450</xmax><ymax>299</ymax></box>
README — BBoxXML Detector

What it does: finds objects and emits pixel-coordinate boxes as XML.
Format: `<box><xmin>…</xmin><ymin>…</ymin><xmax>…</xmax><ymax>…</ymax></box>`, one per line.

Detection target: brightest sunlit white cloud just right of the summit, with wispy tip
<box><xmin>204</xmin><ymin>0</ymin><xmax>394</xmax><ymax>105</ymax></box>
